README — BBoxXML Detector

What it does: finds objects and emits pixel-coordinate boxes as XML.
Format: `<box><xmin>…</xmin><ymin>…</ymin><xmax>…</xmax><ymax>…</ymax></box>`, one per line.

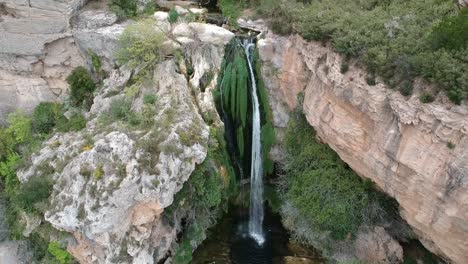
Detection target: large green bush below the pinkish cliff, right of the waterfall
<box><xmin>283</xmin><ymin>114</ymin><xmax>370</xmax><ymax>239</ymax></box>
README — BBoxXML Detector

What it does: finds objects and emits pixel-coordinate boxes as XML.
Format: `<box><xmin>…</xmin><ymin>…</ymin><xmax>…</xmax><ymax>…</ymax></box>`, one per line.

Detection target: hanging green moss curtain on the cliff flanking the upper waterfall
<box><xmin>214</xmin><ymin>38</ymin><xmax>275</xmax><ymax>178</ymax></box>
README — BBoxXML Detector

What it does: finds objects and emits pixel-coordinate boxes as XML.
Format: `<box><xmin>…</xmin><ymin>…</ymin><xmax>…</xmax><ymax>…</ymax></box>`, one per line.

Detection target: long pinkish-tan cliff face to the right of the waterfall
<box><xmin>258</xmin><ymin>33</ymin><xmax>468</xmax><ymax>263</ymax></box>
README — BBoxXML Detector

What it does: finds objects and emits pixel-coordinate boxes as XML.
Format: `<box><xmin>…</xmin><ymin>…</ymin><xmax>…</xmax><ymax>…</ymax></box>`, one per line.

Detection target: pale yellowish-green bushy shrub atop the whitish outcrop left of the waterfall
<box><xmin>116</xmin><ymin>19</ymin><xmax>166</xmax><ymax>67</ymax></box>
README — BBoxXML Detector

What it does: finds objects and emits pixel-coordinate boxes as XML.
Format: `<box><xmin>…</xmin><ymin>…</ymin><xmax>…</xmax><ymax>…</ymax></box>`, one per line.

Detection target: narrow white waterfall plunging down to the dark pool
<box><xmin>243</xmin><ymin>39</ymin><xmax>265</xmax><ymax>245</ymax></box>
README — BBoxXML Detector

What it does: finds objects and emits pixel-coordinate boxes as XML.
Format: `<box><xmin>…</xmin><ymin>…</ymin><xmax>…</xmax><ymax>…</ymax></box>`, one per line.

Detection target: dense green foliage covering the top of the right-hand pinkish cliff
<box><xmin>220</xmin><ymin>0</ymin><xmax>468</xmax><ymax>104</ymax></box>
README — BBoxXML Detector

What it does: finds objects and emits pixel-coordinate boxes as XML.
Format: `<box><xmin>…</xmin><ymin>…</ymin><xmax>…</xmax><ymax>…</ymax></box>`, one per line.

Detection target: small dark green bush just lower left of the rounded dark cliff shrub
<box><xmin>31</xmin><ymin>102</ymin><xmax>62</xmax><ymax>134</ymax></box>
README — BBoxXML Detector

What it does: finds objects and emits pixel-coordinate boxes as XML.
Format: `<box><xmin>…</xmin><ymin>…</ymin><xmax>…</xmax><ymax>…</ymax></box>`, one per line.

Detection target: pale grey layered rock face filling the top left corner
<box><xmin>0</xmin><ymin>0</ymin><xmax>86</xmax><ymax>122</ymax></box>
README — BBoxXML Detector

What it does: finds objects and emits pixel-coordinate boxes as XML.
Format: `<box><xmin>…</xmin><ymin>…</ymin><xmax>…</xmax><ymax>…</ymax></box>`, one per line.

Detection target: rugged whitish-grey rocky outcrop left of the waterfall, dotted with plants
<box><xmin>18</xmin><ymin>15</ymin><xmax>234</xmax><ymax>264</ymax></box>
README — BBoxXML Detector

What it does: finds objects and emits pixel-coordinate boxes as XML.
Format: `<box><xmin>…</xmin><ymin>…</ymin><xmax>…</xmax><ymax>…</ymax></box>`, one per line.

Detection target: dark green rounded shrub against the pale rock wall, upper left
<box><xmin>67</xmin><ymin>66</ymin><xmax>96</xmax><ymax>106</ymax></box>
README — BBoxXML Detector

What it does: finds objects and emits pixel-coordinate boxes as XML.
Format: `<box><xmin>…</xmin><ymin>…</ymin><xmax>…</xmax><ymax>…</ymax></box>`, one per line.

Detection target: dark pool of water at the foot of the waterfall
<box><xmin>192</xmin><ymin>208</ymin><xmax>325</xmax><ymax>264</ymax></box>
